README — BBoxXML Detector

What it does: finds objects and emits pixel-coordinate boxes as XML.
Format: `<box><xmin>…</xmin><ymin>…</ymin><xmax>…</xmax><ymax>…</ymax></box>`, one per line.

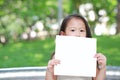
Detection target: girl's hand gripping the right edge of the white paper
<box><xmin>95</xmin><ymin>53</ymin><xmax>106</xmax><ymax>69</ymax></box>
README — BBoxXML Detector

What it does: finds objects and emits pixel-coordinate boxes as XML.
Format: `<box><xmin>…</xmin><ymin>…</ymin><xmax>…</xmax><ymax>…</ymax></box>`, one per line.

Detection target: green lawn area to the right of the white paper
<box><xmin>96</xmin><ymin>35</ymin><xmax>120</xmax><ymax>66</ymax></box>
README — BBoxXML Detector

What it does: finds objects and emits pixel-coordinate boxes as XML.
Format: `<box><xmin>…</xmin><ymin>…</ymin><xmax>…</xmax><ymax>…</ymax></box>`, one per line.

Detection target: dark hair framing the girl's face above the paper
<box><xmin>59</xmin><ymin>14</ymin><xmax>92</xmax><ymax>38</ymax></box>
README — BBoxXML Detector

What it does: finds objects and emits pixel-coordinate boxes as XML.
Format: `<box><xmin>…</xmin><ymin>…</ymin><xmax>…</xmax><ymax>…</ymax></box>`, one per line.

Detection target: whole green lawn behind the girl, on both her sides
<box><xmin>0</xmin><ymin>35</ymin><xmax>120</xmax><ymax>68</ymax></box>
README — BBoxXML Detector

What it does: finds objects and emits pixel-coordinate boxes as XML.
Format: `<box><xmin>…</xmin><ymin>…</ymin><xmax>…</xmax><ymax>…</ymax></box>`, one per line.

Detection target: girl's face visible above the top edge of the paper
<box><xmin>61</xmin><ymin>18</ymin><xmax>86</xmax><ymax>37</ymax></box>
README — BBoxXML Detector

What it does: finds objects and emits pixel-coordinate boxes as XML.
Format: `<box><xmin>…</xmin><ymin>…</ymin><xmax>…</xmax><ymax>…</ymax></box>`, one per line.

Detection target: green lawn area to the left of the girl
<box><xmin>0</xmin><ymin>38</ymin><xmax>54</xmax><ymax>68</ymax></box>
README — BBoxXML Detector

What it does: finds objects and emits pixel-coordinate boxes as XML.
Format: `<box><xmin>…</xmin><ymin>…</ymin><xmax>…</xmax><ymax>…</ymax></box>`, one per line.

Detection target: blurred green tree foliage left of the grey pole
<box><xmin>0</xmin><ymin>0</ymin><xmax>57</xmax><ymax>43</ymax></box>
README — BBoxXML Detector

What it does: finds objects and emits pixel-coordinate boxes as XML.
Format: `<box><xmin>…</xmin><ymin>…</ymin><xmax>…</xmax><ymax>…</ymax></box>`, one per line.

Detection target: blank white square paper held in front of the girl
<box><xmin>54</xmin><ymin>35</ymin><xmax>96</xmax><ymax>77</ymax></box>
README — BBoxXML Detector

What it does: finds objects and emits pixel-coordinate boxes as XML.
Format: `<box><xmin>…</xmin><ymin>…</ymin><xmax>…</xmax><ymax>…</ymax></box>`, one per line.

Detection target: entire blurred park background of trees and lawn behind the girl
<box><xmin>0</xmin><ymin>0</ymin><xmax>120</xmax><ymax>68</ymax></box>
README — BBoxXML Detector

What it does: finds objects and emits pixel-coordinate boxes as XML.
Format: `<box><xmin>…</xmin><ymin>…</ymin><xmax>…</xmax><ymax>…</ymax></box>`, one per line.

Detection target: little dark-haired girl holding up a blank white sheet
<box><xmin>45</xmin><ymin>14</ymin><xmax>106</xmax><ymax>80</ymax></box>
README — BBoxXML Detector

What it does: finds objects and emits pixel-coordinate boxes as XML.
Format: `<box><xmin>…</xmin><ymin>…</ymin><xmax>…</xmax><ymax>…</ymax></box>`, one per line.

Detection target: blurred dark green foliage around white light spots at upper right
<box><xmin>71</xmin><ymin>0</ymin><xmax>117</xmax><ymax>31</ymax></box>
